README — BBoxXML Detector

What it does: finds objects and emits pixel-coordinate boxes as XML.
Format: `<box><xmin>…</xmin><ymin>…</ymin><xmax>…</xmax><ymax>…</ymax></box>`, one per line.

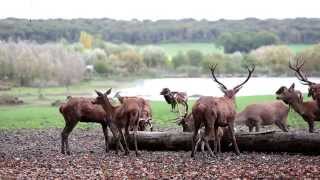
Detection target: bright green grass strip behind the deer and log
<box><xmin>0</xmin><ymin>95</ymin><xmax>320</xmax><ymax>129</ymax></box>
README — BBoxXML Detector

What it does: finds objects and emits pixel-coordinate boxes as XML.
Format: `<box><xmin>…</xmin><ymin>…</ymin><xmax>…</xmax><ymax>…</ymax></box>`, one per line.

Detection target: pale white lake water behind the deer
<box><xmin>113</xmin><ymin>77</ymin><xmax>320</xmax><ymax>100</ymax></box>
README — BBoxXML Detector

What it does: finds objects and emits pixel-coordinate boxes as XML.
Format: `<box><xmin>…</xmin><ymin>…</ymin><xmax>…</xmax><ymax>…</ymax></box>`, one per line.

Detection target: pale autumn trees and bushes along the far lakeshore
<box><xmin>0</xmin><ymin>38</ymin><xmax>320</xmax><ymax>88</ymax></box>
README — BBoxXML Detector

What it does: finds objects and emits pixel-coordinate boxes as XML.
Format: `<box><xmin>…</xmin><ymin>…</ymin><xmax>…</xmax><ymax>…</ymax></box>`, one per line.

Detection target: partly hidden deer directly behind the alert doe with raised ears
<box><xmin>114</xmin><ymin>92</ymin><xmax>153</xmax><ymax>131</ymax></box>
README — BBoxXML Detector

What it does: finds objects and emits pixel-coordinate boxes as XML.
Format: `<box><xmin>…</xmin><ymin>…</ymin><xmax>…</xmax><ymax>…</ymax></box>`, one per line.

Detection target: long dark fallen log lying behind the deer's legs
<box><xmin>111</xmin><ymin>131</ymin><xmax>320</xmax><ymax>154</ymax></box>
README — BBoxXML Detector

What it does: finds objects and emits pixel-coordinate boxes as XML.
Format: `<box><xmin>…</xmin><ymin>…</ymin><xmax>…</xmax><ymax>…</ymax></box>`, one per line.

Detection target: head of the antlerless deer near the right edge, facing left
<box><xmin>276</xmin><ymin>83</ymin><xmax>303</xmax><ymax>106</ymax></box>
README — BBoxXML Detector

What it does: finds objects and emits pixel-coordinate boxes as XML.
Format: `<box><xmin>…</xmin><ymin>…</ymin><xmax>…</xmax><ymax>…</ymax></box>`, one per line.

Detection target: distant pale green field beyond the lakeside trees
<box><xmin>147</xmin><ymin>43</ymin><xmax>311</xmax><ymax>57</ymax></box>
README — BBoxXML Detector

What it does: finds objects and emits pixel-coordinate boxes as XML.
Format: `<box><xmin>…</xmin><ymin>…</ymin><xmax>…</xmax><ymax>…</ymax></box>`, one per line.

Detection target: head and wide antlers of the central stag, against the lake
<box><xmin>209</xmin><ymin>64</ymin><xmax>255</xmax><ymax>99</ymax></box>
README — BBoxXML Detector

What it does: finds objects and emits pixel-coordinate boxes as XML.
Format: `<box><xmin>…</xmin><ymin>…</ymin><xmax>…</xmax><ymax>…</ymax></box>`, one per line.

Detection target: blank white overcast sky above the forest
<box><xmin>0</xmin><ymin>0</ymin><xmax>320</xmax><ymax>20</ymax></box>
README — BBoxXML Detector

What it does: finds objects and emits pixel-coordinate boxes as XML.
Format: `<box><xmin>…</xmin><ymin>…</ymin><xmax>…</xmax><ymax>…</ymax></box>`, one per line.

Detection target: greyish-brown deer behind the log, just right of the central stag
<box><xmin>235</xmin><ymin>101</ymin><xmax>289</xmax><ymax>132</ymax></box>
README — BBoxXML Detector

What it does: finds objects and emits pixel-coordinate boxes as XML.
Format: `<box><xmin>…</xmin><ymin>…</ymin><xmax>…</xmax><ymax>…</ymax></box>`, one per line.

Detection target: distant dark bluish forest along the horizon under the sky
<box><xmin>0</xmin><ymin>18</ymin><xmax>320</xmax><ymax>44</ymax></box>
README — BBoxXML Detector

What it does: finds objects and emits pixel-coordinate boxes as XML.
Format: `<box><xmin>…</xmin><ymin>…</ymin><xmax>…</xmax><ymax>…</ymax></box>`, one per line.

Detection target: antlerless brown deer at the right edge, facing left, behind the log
<box><xmin>276</xmin><ymin>83</ymin><xmax>320</xmax><ymax>133</ymax></box>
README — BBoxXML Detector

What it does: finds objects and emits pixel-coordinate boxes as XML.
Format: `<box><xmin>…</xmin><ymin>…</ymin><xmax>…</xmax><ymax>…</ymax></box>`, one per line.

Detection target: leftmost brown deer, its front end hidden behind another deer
<box><xmin>59</xmin><ymin>96</ymin><xmax>123</xmax><ymax>155</ymax></box>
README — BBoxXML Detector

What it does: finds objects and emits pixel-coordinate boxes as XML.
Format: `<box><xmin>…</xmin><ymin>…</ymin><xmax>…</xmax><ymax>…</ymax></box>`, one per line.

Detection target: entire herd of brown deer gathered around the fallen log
<box><xmin>60</xmin><ymin>60</ymin><xmax>320</xmax><ymax>157</ymax></box>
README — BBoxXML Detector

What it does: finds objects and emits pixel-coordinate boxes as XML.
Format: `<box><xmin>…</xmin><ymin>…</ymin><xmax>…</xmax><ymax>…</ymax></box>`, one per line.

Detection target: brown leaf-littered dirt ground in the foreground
<box><xmin>0</xmin><ymin>129</ymin><xmax>320</xmax><ymax>179</ymax></box>
